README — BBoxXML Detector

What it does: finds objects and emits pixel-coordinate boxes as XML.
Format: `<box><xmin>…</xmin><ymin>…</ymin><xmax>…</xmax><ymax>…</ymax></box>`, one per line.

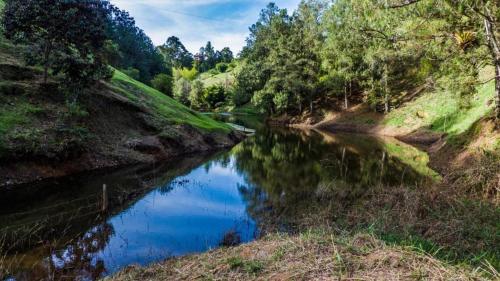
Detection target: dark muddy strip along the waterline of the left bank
<box><xmin>0</xmin><ymin>132</ymin><xmax>245</xmax><ymax>189</ymax></box>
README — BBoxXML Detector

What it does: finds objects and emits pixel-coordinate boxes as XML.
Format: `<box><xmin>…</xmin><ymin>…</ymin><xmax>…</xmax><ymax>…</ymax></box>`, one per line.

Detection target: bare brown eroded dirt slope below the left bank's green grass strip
<box><xmin>0</xmin><ymin>84</ymin><xmax>244</xmax><ymax>187</ymax></box>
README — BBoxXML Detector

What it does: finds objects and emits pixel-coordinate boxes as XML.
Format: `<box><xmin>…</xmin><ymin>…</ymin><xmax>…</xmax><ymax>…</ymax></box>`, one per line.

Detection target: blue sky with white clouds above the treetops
<box><xmin>111</xmin><ymin>0</ymin><xmax>300</xmax><ymax>53</ymax></box>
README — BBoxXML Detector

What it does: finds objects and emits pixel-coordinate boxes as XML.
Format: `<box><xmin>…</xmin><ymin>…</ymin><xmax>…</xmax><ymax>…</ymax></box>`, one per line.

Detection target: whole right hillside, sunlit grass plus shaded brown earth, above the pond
<box><xmin>318</xmin><ymin>70</ymin><xmax>500</xmax><ymax>148</ymax></box>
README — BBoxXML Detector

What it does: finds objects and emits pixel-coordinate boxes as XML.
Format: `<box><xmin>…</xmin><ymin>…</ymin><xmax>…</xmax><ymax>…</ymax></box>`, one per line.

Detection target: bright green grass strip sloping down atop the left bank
<box><xmin>111</xmin><ymin>70</ymin><xmax>231</xmax><ymax>133</ymax></box>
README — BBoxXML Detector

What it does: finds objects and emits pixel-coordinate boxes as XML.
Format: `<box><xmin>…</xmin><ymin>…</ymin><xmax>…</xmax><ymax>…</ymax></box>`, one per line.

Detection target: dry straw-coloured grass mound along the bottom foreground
<box><xmin>107</xmin><ymin>231</ymin><xmax>492</xmax><ymax>281</ymax></box>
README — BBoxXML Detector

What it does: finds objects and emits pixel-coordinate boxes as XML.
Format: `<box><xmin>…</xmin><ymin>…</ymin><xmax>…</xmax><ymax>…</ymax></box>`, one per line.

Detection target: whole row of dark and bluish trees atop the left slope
<box><xmin>2</xmin><ymin>0</ymin><xmax>172</xmax><ymax>94</ymax></box>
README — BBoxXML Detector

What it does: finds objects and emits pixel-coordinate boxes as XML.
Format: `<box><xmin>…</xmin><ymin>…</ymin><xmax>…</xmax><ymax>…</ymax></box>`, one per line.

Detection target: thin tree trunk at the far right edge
<box><xmin>484</xmin><ymin>16</ymin><xmax>500</xmax><ymax>123</ymax></box>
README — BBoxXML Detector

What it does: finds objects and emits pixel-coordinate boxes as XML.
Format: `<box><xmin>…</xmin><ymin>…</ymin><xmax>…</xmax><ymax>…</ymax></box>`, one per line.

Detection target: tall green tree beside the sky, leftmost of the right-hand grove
<box><xmin>236</xmin><ymin>0</ymin><xmax>326</xmax><ymax>114</ymax></box>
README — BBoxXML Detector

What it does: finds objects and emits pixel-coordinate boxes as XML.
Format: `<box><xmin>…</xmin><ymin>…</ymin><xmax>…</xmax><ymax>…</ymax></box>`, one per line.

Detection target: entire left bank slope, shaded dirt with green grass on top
<box><xmin>0</xmin><ymin>20</ymin><xmax>241</xmax><ymax>186</ymax></box>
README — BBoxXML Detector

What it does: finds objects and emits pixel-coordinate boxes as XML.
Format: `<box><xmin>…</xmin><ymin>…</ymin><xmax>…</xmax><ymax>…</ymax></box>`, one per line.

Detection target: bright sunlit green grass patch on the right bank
<box><xmin>384</xmin><ymin>81</ymin><xmax>495</xmax><ymax>137</ymax></box>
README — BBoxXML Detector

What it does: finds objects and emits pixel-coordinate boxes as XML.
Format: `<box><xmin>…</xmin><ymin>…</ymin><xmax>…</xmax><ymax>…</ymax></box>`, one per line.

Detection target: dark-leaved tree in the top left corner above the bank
<box><xmin>2</xmin><ymin>0</ymin><xmax>109</xmax><ymax>89</ymax></box>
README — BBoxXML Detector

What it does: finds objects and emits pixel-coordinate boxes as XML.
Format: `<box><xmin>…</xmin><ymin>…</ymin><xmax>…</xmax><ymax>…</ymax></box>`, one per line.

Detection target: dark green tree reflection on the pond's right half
<box><xmin>232</xmin><ymin>130</ymin><xmax>433</xmax><ymax>230</ymax></box>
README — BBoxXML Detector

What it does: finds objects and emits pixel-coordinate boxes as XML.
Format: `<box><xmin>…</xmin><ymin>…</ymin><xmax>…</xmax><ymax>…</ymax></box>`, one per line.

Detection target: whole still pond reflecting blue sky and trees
<box><xmin>0</xmin><ymin>123</ymin><xmax>438</xmax><ymax>280</ymax></box>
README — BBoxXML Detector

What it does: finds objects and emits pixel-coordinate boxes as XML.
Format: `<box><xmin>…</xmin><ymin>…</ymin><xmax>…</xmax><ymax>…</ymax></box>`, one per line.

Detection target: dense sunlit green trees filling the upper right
<box><xmin>235</xmin><ymin>0</ymin><xmax>500</xmax><ymax>121</ymax></box>
